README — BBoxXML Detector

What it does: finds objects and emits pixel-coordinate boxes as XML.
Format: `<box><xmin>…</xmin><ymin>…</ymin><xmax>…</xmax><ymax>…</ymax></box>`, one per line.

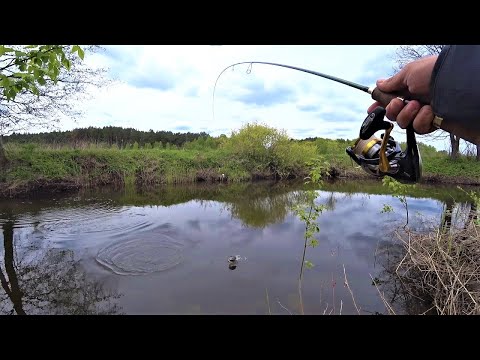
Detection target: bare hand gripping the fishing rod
<box><xmin>367</xmin><ymin>55</ymin><xmax>437</xmax><ymax>134</ymax></box>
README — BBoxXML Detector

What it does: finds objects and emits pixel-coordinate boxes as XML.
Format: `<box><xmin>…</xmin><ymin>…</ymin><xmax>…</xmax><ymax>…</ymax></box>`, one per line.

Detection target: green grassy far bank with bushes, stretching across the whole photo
<box><xmin>0</xmin><ymin>124</ymin><xmax>480</xmax><ymax>196</ymax></box>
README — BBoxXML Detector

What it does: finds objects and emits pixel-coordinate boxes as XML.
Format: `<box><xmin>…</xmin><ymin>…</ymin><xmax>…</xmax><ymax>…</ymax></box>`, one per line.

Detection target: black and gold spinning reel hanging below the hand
<box><xmin>346</xmin><ymin>106</ymin><xmax>422</xmax><ymax>183</ymax></box>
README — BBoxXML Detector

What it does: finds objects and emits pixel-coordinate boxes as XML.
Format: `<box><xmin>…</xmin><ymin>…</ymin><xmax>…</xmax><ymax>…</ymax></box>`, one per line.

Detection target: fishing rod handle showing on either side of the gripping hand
<box><xmin>369</xmin><ymin>88</ymin><xmax>480</xmax><ymax>145</ymax></box>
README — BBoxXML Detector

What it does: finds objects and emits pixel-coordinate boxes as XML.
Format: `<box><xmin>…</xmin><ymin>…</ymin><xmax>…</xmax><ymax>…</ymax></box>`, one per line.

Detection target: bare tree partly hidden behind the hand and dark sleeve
<box><xmin>395</xmin><ymin>45</ymin><xmax>472</xmax><ymax>160</ymax></box>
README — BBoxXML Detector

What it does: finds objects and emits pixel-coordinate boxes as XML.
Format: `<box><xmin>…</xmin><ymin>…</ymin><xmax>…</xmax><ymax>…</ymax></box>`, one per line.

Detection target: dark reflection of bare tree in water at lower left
<box><xmin>0</xmin><ymin>221</ymin><xmax>121</xmax><ymax>315</ymax></box>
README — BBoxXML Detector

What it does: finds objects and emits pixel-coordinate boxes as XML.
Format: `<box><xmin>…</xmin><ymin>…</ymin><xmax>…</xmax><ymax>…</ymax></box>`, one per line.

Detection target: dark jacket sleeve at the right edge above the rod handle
<box><xmin>430</xmin><ymin>45</ymin><xmax>480</xmax><ymax>129</ymax></box>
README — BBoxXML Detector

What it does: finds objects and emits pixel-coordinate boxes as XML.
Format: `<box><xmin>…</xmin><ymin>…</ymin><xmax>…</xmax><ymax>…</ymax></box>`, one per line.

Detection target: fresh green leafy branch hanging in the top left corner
<box><xmin>0</xmin><ymin>45</ymin><xmax>85</xmax><ymax>101</ymax></box>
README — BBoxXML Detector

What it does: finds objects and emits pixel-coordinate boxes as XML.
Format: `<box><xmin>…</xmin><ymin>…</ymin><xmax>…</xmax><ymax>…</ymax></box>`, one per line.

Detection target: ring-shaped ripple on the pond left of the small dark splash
<box><xmin>96</xmin><ymin>235</ymin><xmax>184</xmax><ymax>275</ymax></box>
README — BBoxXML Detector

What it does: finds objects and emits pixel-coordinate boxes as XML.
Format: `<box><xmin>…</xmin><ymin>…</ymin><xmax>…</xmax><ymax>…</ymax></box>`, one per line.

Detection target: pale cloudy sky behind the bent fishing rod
<box><xmin>61</xmin><ymin>45</ymin><xmax>450</xmax><ymax>148</ymax></box>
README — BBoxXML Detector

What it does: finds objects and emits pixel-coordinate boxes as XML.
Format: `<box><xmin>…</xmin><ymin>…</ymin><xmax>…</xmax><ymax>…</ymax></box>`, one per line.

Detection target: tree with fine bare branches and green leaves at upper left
<box><xmin>0</xmin><ymin>45</ymin><xmax>106</xmax><ymax>168</ymax></box>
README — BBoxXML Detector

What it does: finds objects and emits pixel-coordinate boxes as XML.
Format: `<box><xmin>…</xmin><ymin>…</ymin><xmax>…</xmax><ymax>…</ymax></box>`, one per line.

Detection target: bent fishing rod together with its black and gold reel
<box><xmin>212</xmin><ymin>61</ymin><xmax>428</xmax><ymax>183</ymax></box>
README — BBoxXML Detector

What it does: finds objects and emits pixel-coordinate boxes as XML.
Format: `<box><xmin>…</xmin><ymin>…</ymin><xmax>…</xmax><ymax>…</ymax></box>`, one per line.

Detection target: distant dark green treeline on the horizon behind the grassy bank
<box><xmin>4</xmin><ymin>126</ymin><xmax>210</xmax><ymax>148</ymax></box>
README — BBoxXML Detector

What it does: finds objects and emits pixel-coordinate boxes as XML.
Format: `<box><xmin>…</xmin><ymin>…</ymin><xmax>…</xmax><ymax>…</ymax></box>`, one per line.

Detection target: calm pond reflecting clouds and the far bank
<box><xmin>0</xmin><ymin>180</ymin><xmax>469</xmax><ymax>315</ymax></box>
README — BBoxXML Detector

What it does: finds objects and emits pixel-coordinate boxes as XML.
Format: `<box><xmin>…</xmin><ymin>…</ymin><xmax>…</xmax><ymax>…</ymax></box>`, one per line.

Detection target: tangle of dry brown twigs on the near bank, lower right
<box><xmin>382</xmin><ymin>217</ymin><xmax>480</xmax><ymax>315</ymax></box>
